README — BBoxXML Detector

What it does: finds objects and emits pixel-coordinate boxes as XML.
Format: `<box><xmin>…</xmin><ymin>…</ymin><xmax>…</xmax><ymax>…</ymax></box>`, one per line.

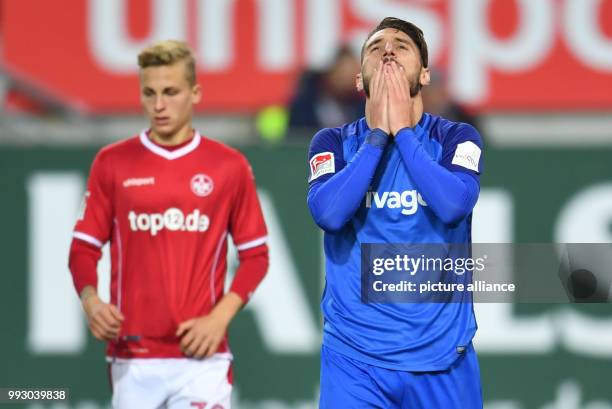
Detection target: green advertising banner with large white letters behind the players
<box><xmin>0</xmin><ymin>146</ymin><xmax>612</xmax><ymax>409</ymax></box>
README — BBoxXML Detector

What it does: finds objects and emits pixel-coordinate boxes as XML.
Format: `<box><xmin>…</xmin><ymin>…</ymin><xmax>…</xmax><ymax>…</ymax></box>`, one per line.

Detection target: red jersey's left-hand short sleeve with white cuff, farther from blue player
<box><xmin>73</xmin><ymin>152</ymin><xmax>113</xmax><ymax>247</ymax></box>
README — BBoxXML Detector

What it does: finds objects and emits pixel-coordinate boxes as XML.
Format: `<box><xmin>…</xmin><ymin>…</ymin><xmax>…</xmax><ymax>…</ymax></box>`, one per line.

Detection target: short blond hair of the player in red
<box><xmin>138</xmin><ymin>40</ymin><xmax>196</xmax><ymax>85</ymax></box>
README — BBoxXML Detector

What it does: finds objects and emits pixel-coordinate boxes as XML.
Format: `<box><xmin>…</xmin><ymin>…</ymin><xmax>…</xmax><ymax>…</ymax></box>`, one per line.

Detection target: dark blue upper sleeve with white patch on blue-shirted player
<box><xmin>440</xmin><ymin>123</ymin><xmax>483</xmax><ymax>180</ymax></box>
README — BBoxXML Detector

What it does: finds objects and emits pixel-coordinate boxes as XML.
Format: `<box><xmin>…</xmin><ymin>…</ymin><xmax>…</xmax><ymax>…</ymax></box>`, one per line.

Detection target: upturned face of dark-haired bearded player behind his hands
<box><xmin>358</xmin><ymin>28</ymin><xmax>427</xmax><ymax>98</ymax></box>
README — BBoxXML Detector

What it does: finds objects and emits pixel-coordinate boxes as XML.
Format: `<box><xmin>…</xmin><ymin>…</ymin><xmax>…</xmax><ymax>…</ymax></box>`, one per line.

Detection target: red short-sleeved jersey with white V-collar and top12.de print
<box><xmin>74</xmin><ymin>132</ymin><xmax>267</xmax><ymax>358</ymax></box>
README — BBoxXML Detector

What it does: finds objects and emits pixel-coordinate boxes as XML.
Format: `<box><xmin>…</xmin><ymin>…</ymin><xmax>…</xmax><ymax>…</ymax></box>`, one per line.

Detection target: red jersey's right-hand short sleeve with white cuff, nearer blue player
<box><xmin>229</xmin><ymin>157</ymin><xmax>268</xmax><ymax>251</ymax></box>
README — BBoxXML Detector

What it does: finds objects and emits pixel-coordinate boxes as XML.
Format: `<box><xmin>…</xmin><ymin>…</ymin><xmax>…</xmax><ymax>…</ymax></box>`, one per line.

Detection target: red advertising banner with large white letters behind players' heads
<box><xmin>0</xmin><ymin>0</ymin><xmax>612</xmax><ymax>113</ymax></box>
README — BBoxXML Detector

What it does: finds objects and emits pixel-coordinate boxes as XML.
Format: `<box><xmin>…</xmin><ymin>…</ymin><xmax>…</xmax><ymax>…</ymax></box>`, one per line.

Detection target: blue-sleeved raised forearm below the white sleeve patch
<box><xmin>396</xmin><ymin>128</ymin><xmax>479</xmax><ymax>225</ymax></box>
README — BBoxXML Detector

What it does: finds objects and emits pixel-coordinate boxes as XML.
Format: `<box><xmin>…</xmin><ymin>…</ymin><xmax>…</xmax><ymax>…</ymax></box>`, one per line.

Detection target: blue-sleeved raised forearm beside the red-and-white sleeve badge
<box><xmin>308</xmin><ymin>130</ymin><xmax>388</xmax><ymax>232</ymax></box>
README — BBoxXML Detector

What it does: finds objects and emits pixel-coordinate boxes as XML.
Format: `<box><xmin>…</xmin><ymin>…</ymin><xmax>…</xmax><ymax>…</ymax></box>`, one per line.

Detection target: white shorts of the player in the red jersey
<box><xmin>111</xmin><ymin>354</ymin><xmax>232</xmax><ymax>409</ymax></box>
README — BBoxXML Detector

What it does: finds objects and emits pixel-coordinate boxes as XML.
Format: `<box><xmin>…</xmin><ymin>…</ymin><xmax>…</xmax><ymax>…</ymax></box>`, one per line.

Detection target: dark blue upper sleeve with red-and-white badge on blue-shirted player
<box><xmin>308</xmin><ymin>128</ymin><xmax>346</xmax><ymax>186</ymax></box>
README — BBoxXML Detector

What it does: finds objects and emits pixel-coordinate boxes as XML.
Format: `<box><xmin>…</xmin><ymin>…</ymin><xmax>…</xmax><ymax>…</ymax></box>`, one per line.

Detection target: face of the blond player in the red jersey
<box><xmin>140</xmin><ymin>61</ymin><xmax>201</xmax><ymax>137</ymax></box>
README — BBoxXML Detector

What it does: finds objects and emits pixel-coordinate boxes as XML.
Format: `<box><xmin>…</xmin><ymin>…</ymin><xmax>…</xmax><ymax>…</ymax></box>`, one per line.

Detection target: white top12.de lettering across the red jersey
<box><xmin>128</xmin><ymin>207</ymin><xmax>210</xmax><ymax>236</ymax></box>
